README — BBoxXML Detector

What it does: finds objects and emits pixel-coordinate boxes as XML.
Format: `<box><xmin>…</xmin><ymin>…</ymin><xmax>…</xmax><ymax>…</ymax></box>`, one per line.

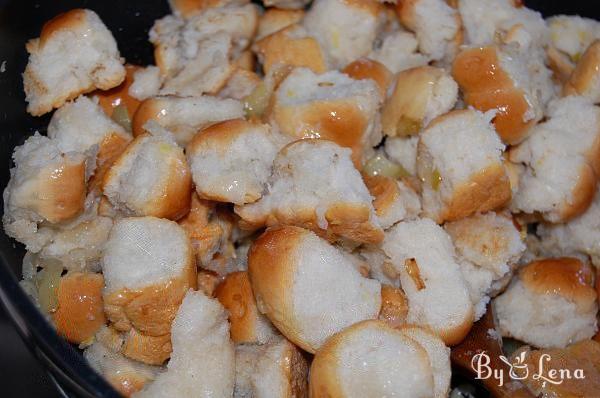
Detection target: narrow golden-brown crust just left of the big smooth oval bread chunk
<box><xmin>215</xmin><ymin>271</ymin><xmax>260</xmax><ymax>344</ymax></box>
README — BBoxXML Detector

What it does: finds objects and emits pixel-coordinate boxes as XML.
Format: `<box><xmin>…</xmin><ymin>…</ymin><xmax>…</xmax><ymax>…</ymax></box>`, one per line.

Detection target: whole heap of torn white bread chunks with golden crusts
<box><xmin>3</xmin><ymin>0</ymin><xmax>600</xmax><ymax>398</ymax></box>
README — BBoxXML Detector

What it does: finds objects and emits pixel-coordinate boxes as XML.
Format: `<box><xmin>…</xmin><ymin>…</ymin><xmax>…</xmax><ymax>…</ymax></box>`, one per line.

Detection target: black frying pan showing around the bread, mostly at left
<box><xmin>0</xmin><ymin>0</ymin><xmax>600</xmax><ymax>397</ymax></box>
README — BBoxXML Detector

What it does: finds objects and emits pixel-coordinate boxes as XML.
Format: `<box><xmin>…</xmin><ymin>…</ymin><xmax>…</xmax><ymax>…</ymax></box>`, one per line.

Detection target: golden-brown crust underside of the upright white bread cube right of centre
<box><xmin>438</xmin><ymin>163</ymin><xmax>512</xmax><ymax>222</ymax></box>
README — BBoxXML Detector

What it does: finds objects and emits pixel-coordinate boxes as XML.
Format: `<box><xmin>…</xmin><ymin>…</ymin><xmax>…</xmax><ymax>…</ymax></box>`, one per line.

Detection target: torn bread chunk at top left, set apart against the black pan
<box><xmin>23</xmin><ymin>8</ymin><xmax>125</xmax><ymax>116</ymax></box>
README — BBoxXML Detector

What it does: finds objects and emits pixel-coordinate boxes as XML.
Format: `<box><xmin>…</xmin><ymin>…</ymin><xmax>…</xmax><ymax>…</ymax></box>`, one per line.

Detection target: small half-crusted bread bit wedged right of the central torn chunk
<box><xmin>363</xmin><ymin>176</ymin><xmax>421</xmax><ymax>229</ymax></box>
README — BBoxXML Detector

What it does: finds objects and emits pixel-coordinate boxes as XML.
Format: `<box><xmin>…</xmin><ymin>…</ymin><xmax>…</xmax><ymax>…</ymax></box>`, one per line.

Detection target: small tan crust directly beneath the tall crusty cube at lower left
<box><xmin>121</xmin><ymin>328</ymin><xmax>173</xmax><ymax>365</ymax></box>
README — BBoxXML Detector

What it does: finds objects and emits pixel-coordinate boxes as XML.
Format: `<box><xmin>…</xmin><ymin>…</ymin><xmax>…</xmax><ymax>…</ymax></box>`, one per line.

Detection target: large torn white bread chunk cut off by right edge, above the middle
<box><xmin>509</xmin><ymin>96</ymin><xmax>600</xmax><ymax>222</ymax></box>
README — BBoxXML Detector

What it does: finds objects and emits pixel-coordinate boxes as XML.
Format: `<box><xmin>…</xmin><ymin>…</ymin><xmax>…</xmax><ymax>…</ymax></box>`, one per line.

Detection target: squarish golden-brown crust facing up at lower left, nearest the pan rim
<box><xmin>52</xmin><ymin>272</ymin><xmax>106</xmax><ymax>344</ymax></box>
